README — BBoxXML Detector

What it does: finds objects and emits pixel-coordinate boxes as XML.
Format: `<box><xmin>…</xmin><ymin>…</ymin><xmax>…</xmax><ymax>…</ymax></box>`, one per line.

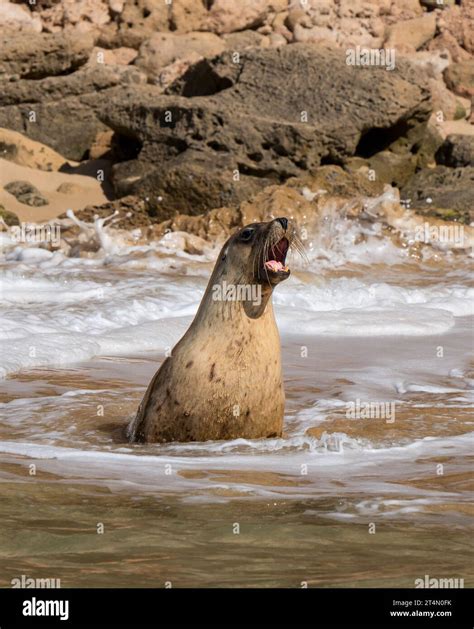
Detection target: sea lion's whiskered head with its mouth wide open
<box><xmin>221</xmin><ymin>217</ymin><xmax>296</xmax><ymax>289</ymax></box>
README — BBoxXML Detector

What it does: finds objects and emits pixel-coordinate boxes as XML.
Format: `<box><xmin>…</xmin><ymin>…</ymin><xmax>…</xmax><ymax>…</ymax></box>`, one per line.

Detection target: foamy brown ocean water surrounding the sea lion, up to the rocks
<box><xmin>0</xmin><ymin>210</ymin><xmax>474</xmax><ymax>587</ymax></box>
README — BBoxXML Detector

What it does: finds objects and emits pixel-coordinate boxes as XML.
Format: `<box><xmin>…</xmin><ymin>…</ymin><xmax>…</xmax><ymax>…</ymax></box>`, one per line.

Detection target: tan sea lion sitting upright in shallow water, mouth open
<box><xmin>129</xmin><ymin>217</ymin><xmax>299</xmax><ymax>443</ymax></box>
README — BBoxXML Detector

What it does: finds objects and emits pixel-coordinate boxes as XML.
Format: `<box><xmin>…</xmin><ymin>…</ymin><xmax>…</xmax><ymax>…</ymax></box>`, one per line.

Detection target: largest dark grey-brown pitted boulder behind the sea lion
<box><xmin>101</xmin><ymin>44</ymin><xmax>431</xmax><ymax>214</ymax></box>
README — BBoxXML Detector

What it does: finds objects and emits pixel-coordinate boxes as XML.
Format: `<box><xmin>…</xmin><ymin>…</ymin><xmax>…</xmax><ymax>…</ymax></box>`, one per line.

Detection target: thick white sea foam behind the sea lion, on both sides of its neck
<box><xmin>0</xmin><ymin>260</ymin><xmax>474</xmax><ymax>375</ymax></box>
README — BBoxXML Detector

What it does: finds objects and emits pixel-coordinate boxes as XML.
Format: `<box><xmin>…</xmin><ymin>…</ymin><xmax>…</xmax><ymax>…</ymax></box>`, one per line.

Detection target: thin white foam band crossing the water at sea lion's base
<box><xmin>0</xmin><ymin>433</ymin><xmax>473</xmax><ymax>500</ymax></box>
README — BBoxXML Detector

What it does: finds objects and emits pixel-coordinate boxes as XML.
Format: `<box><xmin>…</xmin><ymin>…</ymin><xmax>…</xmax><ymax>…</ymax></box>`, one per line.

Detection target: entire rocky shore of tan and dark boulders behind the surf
<box><xmin>0</xmin><ymin>0</ymin><xmax>468</xmax><ymax>231</ymax></box>
